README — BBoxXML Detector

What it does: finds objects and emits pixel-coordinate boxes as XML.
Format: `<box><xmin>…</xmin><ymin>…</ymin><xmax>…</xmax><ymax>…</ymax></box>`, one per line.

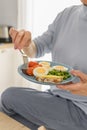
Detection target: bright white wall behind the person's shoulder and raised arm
<box><xmin>27</xmin><ymin>0</ymin><xmax>81</xmax><ymax>37</ymax></box>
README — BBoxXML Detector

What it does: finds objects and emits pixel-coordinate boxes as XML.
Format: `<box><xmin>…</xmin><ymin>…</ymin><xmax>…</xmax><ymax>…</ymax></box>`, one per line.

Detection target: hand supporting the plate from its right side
<box><xmin>57</xmin><ymin>70</ymin><xmax>87</xmax><ymax>96</ymax></box>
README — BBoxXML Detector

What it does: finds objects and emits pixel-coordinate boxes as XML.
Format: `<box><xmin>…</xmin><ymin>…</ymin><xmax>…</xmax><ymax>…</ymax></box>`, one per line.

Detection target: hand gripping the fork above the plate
<box><xmin>9</xmin><ymin>28</ymin><xmax>31</xmax><ymax>50</ymax></box>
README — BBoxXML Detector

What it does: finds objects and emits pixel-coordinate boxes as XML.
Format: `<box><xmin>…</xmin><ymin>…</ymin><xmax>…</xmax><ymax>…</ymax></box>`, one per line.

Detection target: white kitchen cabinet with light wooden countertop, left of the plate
<box><xmin>0</xmin><ymin>43</ymin><xmax>41</xmax><ymax>92</ymax></box>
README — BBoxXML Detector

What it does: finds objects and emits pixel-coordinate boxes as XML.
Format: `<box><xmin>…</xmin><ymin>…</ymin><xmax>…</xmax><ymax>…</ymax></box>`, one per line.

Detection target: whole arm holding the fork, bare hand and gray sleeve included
<box><xmin>9</xmin><ymin>7</ymin><xmax>64</xmax><ymax>57</ymax></box>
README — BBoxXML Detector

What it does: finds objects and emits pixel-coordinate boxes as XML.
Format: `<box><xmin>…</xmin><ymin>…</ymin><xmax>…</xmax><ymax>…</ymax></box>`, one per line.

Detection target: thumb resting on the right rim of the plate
<box><xmin>71</xmin><ymin>70</ymin><xmax>87</xmax><ymax>82</ymax></box>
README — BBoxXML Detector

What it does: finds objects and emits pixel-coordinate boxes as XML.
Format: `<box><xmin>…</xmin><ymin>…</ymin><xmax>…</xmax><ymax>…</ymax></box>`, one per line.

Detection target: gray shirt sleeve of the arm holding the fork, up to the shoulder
<box><xmin>34</xmin><ymin>6</ymin><xmax>74</xmax><ymax>57</ymax></box>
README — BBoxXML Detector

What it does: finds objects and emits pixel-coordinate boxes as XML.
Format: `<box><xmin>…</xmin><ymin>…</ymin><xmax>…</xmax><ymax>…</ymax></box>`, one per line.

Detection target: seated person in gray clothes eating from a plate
<box><xmin>1</xmin><ymin>0</ymin><xmax>87</xmax><ymax>130</ymax></box>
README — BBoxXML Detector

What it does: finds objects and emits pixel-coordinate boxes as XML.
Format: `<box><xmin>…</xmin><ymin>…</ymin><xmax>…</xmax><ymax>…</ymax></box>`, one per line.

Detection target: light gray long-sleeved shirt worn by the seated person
<box><xmin>34</xmin><ymin>5</ymin><xmax>87</xmax><ymax>114</ymax></box>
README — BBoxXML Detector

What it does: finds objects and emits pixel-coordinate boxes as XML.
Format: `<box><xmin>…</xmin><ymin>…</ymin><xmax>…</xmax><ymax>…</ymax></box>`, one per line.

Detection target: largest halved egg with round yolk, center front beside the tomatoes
<box><xmin>33</xmin><ymin>67</ymin><xmax>48</xmax><ymax>77</ymax></box>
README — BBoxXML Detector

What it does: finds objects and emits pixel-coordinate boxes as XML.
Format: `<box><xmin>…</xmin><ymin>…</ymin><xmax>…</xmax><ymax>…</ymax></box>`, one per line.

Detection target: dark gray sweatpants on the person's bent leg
<box><xmin>1</xmin><ymin>87</ymin><xmax>87</xmax><ymax>130</ymax></box>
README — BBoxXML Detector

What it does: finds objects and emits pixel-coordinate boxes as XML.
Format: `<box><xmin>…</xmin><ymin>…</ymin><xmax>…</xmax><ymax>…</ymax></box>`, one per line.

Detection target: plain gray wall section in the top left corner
<box><xmin>0</xmin><ymin>0</ymin><xmax>18</xmax><ymax>27</ymax></box>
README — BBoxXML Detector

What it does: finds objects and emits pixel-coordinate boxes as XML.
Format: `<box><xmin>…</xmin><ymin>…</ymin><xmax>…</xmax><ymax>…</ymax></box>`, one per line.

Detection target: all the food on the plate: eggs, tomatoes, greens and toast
<box><xmin>23</xmin><ymin>61</ymin><xmax>71</xmax><ymax>83</ymax></box>
